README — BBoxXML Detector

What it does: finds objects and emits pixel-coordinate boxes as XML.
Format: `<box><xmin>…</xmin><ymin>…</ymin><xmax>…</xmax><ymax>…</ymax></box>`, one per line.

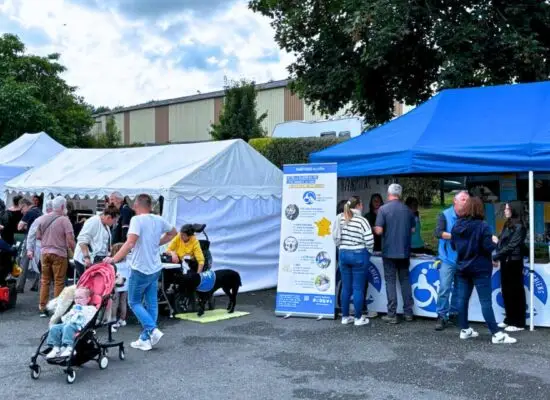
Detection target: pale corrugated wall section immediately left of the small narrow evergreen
<box><xmin>168</xmin><ymin>99</ymin><xmax>215</xmax><ymax>142</ymax></box>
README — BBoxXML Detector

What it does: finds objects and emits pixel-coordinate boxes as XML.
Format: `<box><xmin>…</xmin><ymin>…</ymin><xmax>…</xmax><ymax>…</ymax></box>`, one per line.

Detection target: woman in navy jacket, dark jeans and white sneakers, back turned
<box><xmin>451</xmin><ymin>197</ymin><xmax>516</xmax><ymax>344</ymax></box>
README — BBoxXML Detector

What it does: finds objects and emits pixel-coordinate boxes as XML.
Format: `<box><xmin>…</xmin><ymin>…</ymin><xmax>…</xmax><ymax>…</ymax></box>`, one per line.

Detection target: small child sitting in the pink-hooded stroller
<box><xmin>46</xmin><ymin>288</ymin><xmax>97</xmax><ymax>358</ymax></box>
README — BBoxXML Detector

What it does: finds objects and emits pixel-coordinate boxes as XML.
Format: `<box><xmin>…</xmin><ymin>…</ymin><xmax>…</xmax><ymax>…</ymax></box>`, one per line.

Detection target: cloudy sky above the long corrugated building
<box><xmin>0</xmin><ymin>0</ymin><xmax>292</xmax><ymax>107</ymax></box>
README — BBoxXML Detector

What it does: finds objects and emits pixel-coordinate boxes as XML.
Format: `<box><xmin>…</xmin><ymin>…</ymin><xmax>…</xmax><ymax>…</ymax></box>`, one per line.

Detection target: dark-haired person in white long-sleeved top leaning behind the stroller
<box><xmin>74</xmin><ymin>205</ymin><xmax>118</xmax><ymax>273</ymax></box>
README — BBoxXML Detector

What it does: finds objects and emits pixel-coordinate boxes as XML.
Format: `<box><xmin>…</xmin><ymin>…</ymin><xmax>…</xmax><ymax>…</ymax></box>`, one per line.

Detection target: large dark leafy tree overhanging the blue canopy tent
<box><xmin>249</xmin><ymin>0</ymin><xmax>550</xmax><ymax>125</ymax></box>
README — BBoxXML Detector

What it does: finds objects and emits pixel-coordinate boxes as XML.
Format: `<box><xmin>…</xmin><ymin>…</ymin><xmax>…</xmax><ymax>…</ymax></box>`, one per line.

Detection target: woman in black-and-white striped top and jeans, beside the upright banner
<box><xmin>338</xmin><ymin>196</ymin><xmax>374</xmax><ymax>326</ymax></box>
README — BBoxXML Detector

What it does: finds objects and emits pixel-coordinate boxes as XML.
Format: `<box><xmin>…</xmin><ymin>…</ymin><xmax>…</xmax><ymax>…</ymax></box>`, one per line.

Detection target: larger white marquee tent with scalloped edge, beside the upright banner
<box><xmin>6</xmin><ymin>140</ymin><xmax>283</xmax><ymax>291</ymax></box>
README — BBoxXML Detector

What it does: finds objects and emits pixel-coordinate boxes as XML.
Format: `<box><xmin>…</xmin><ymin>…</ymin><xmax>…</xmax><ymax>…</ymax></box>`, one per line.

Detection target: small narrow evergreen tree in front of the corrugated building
<box><xmin>211</xmin><ymin>79</ymin><xmax>267</xmax><ymax>142</ymax></box>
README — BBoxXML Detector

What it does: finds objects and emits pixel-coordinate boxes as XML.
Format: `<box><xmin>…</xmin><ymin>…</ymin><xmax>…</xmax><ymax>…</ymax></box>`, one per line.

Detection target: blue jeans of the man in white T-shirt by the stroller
<box><xmin>128</xmin><ymin>270</ymin><xmax>161</xmax><ymax>340</ymax></box>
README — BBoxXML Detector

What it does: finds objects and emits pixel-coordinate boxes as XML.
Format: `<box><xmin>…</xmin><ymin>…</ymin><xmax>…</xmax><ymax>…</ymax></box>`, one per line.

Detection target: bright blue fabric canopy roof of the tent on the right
<box><xmin>309</xmin><ymin>81</ymin><xmax>550</xmax><ymax>177</ymax></box>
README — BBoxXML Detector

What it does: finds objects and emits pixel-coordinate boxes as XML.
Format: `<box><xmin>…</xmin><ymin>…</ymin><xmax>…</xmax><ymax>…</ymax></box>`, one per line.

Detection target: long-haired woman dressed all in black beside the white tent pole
<box><xmin>493</xmin><ymin>204</ymin><xmax>527</xmax><ymax>332</ymax></box>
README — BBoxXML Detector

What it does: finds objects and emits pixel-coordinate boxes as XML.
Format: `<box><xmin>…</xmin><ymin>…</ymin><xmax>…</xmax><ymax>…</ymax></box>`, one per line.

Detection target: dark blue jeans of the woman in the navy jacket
<box><xmin>456</xmin><ymin>270</ymin><xmax>499</xmax><ymax>335</ymax></box>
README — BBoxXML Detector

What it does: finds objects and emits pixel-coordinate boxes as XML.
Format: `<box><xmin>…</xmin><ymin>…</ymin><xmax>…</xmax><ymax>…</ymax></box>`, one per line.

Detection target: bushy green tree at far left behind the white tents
<box><xmin>0</xmin><ymin>34</ymin><xmax>94</xmax><ymax>146</ymax></box>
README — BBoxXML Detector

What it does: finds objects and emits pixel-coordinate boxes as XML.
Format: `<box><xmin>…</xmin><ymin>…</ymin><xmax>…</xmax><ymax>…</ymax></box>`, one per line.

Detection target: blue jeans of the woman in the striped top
<box><xmin>339</xmin><ymin>249</ymin><xmax>370</xmax><ymax>319</ymax></box>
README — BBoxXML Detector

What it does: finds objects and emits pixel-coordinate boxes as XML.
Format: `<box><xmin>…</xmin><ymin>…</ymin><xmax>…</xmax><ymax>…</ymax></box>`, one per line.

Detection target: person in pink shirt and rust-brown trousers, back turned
<box><xmin>36</xmin><ymin>196</ymin><xmax>75</xmax><ymax>318</ymax></box>
